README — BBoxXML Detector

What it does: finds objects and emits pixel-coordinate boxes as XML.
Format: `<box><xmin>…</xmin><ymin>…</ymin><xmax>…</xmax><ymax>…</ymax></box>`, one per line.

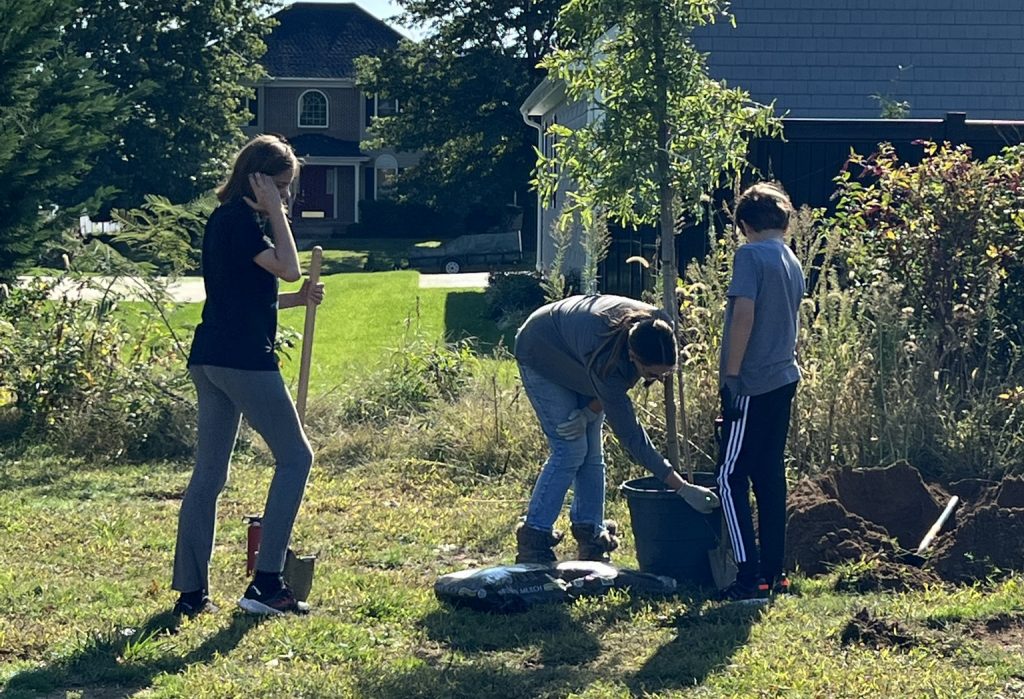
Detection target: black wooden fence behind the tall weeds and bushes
<box><xmin>598</xmin><ymin>113</ymin><xmax>1024</xmax><ymax>298</ymax></box>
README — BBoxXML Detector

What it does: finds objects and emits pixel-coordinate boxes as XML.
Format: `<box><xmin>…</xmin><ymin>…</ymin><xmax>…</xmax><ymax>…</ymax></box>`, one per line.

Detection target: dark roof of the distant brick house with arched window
<box><xmin>260</xmin><ymin>2</ymin><xmax>404</xmax><ymax>78</ymax></box>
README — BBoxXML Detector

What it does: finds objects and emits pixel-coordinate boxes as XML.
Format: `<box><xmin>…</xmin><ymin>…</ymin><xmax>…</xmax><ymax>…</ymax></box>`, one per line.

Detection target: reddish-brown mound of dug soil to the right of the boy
<box><xmin>786</xmin><ymin>464</ymin><xmax>1024</xmax><ymax>588</ymax></box>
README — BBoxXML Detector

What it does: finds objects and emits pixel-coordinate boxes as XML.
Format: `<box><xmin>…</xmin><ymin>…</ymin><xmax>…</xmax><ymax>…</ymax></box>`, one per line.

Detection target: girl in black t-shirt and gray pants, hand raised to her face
<box><xmin>172</xmin><ymin>135</ymin><xmax>324</xmax><ymax>617</ymax></box>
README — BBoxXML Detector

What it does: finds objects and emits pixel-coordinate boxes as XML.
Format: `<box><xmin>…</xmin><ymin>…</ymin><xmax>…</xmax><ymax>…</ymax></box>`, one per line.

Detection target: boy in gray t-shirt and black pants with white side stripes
<box><xmin>718</xmin><ymin>182</ymin><xmax>804</xmax><ymax>600</ymax></box>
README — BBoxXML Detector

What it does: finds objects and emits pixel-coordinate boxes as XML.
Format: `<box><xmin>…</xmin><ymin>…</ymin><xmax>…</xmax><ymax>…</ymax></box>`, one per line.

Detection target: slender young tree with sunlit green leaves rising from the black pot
<box><xmin>538</xmin><ymin>0</ymin><xmax>781</xmax><ymax>467</ymax></box>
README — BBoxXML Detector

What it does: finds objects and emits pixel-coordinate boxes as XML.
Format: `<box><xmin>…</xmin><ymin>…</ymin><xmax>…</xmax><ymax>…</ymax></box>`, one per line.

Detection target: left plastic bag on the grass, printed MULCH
<box><xmin>434</xmin><ymin>564</ymin><xmax>570</xmax><ymax>612</ymax></box>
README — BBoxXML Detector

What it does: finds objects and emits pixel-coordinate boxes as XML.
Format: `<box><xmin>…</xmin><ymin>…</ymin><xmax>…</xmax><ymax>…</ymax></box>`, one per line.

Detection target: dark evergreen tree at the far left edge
<box><xmin>0</xmin><ymin>0</ymin><xmax>121</xmax><ymax>280</ymax></box>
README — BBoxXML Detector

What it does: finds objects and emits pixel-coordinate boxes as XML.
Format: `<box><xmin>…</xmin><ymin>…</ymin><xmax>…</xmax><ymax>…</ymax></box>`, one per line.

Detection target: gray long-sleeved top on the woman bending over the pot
<box><xmin>515</xmin><ymin>295</ymin><xmax>672</xmax><ymax>480</ymax></box>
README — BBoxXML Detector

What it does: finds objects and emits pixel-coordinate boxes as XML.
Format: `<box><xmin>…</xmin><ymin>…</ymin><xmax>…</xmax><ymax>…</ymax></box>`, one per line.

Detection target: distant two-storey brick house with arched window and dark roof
<box><xmin>246</xmin><ymin>2</ymin><xmax>418</xmax><ymax>237</ymax></box>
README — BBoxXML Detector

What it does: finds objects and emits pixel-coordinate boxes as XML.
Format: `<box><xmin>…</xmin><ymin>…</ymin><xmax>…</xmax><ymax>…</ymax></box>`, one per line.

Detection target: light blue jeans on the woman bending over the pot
<box><xmin>519</xmin><ymin>364</ymin><xmax>604</xmax><ymax>531</ymax></box>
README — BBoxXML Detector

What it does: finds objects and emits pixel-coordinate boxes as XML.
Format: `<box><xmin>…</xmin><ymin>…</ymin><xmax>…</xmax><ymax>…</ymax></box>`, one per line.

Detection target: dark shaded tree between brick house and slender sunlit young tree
<box><xmin>358</xmin><ymin>0</ymin><xmax>563</xmax><ymax>235</ymax></box>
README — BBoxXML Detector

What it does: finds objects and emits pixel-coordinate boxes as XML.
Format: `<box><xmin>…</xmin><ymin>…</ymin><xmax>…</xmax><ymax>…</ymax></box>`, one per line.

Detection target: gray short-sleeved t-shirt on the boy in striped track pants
<box><xmin>719</xmin><ymin>238</ymin><xmax>804</xmax><ymax>396</ymax></box>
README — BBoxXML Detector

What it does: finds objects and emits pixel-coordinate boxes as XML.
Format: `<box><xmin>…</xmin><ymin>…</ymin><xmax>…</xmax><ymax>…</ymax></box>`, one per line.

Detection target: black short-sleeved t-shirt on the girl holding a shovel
<box><xmin>188</xmin><ymin>200</ymin><xmax>278</xmax><ymax>372</ymax></box>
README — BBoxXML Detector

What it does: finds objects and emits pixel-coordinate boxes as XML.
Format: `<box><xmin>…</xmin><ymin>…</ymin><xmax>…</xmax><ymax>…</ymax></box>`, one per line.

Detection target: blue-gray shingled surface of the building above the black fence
<box><xmin>693</xmin><ymin>0</ymin><xmax>1024</xmax><ymax>120</ymax></box>
